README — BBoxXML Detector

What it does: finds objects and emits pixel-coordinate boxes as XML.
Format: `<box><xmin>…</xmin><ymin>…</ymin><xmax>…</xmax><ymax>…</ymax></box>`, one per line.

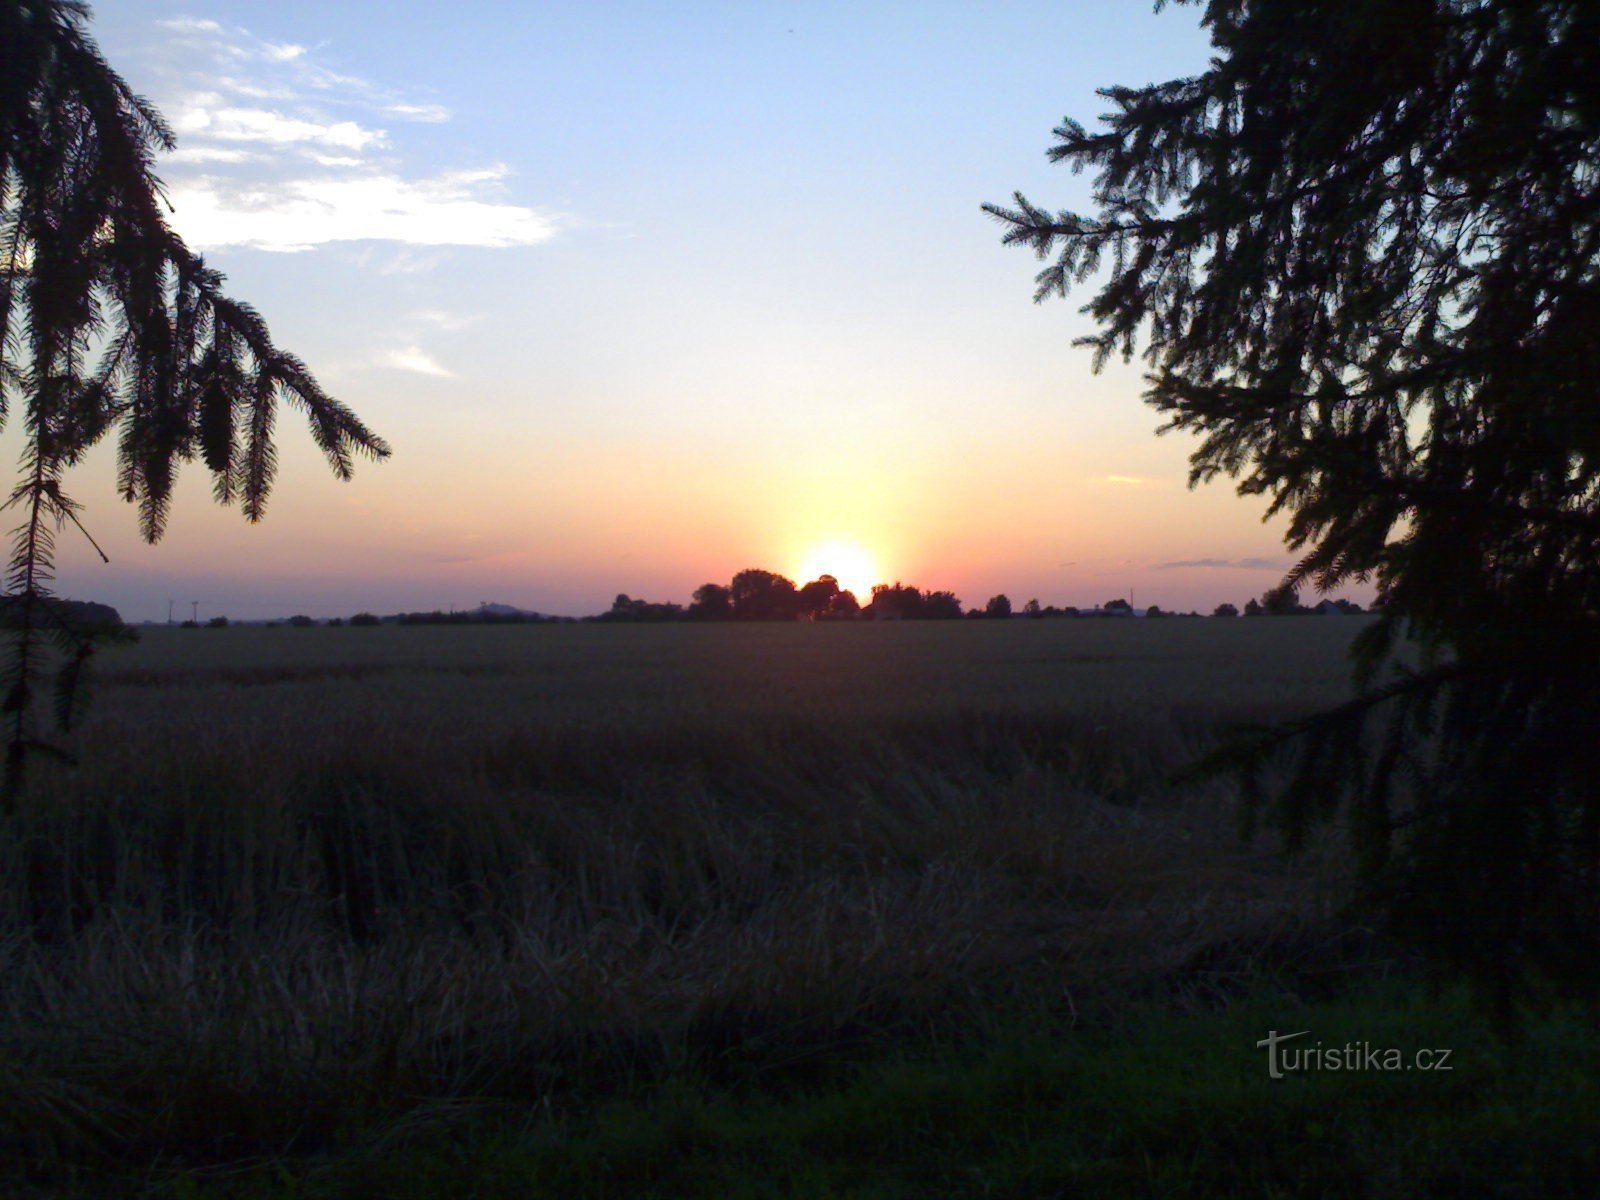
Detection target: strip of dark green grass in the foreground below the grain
<box><xmin>137</xmin><ymin>986</ymin><xmax>1600</xmax><ymax>1200</ymax></box>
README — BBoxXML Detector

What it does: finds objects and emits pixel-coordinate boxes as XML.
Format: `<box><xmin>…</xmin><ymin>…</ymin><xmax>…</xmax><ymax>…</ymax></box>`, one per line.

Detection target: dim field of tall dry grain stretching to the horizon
<box><xmin>0</xmin><ymin>618</ymin><xmax>1595</xmax><ymax>1195</ymax></box>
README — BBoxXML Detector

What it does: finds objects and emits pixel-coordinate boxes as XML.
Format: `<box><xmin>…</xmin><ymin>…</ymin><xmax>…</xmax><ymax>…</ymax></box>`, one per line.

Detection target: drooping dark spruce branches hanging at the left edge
<box><xmin>0</xmin><ymin>0</ymin><xmax>389</xmax><ymax>798</ymax></box>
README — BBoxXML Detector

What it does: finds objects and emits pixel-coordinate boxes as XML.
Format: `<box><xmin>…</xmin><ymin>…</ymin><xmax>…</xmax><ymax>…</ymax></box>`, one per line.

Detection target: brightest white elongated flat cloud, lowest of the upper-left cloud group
<box><xmin>168</xmin><ymin>170</ymin><xmax>557</xmax><ymax>251</ymax></box>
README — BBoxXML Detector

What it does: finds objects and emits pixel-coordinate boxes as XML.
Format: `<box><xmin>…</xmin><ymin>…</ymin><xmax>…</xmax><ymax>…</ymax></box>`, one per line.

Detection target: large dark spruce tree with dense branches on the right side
<box><xmin>989</xmin><ymin>0</ymin><xmax>1600</xmax><ymax>1016</ymax></box>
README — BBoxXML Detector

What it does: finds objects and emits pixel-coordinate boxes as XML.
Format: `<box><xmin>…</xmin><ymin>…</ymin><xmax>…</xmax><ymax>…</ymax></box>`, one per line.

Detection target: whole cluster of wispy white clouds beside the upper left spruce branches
<box><xmin>139</xmin><ymin>16</ymin><xmax>562</xmax><ymax>259</ymax></box>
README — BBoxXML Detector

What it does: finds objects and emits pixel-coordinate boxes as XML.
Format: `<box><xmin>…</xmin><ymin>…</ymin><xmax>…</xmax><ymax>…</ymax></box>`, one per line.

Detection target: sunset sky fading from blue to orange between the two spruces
<box><xmin>43</xmin><ymin>0</ymin><xmax>1356</xmax><ymax>621</ymax></box>
